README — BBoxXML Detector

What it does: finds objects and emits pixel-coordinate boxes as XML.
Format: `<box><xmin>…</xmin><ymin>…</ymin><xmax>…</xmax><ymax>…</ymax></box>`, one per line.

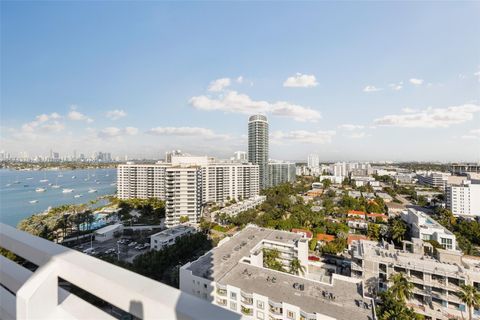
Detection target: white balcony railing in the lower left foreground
<box><xmin>0</xmin><ymin>224</ymin><xmax>241</xmax><ymax>319</ymax></box>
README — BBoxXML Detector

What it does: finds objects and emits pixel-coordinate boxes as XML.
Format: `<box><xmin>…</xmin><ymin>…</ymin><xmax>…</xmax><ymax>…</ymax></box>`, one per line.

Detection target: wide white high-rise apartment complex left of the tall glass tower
<box><xmin>117</xmin><ymin>158</ymin><xmax>260</xmax><ymax>227</ymax></box>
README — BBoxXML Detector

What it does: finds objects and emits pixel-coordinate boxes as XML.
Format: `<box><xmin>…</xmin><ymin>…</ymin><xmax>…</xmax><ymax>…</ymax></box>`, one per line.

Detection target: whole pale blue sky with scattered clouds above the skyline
<box><xmin>0</xmin><ymin>1</ymin><xmax>480</xmax><ymax>161</ymax></box>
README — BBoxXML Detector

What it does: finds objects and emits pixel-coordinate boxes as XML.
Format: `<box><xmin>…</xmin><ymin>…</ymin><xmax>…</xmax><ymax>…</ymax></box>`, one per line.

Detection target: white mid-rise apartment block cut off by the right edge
<box><xmin>445</xmin><ymin>181</ymin><xmax>480</xmax><ymax>218</ymax></box>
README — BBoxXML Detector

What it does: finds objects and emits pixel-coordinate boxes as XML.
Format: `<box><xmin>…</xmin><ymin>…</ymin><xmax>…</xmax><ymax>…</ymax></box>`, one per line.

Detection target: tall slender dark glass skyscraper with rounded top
<box><xmin>248</xmin><ymin>114</ymin><xmax>268</xmax><ymax>189</ymax></box>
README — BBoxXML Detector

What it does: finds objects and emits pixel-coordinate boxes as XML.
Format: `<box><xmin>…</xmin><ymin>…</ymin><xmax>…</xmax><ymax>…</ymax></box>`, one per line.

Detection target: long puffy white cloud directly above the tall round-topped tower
<box><xmin>189</xmin><ymin>91</ymin><xmax>321</xmax><ymax>122</ymax></box>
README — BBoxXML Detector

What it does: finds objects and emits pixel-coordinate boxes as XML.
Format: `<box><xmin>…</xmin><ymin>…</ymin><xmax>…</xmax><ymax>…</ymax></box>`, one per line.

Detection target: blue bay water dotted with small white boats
<box><xmin>0</xmin><ymin>169</ymin><xmax>117</xmax><ymax>226</ymax></box>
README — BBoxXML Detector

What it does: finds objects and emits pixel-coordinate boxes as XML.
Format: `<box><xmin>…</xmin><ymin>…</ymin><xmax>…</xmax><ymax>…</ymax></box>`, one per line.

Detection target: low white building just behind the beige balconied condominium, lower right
<box><xmin>401</xmin><ymin>208</ymin><xmax>457</xmax><ymax>251</ymax></box>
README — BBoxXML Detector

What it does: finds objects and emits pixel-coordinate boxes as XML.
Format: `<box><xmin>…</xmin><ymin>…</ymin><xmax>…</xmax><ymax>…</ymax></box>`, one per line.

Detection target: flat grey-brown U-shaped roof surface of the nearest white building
<box><xmin>187</xmin><ymin>226</ymin><xmax>373</xmax><ymax>320</ymax></box>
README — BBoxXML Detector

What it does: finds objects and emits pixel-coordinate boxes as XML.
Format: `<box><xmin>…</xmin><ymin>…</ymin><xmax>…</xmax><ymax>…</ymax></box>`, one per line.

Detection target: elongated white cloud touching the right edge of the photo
<box><xmin>374</xmin><ymin>104</ymin><xmax>480</xmax><ymax>128</ymax></box>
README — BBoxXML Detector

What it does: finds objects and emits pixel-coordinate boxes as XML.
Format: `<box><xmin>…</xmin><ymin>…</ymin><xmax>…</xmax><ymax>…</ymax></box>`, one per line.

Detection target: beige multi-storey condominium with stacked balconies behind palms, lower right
<box><xmin>351</xmin><ymin>238</ymin><xmax>480</xmax><ymax>320</ymax></box>
